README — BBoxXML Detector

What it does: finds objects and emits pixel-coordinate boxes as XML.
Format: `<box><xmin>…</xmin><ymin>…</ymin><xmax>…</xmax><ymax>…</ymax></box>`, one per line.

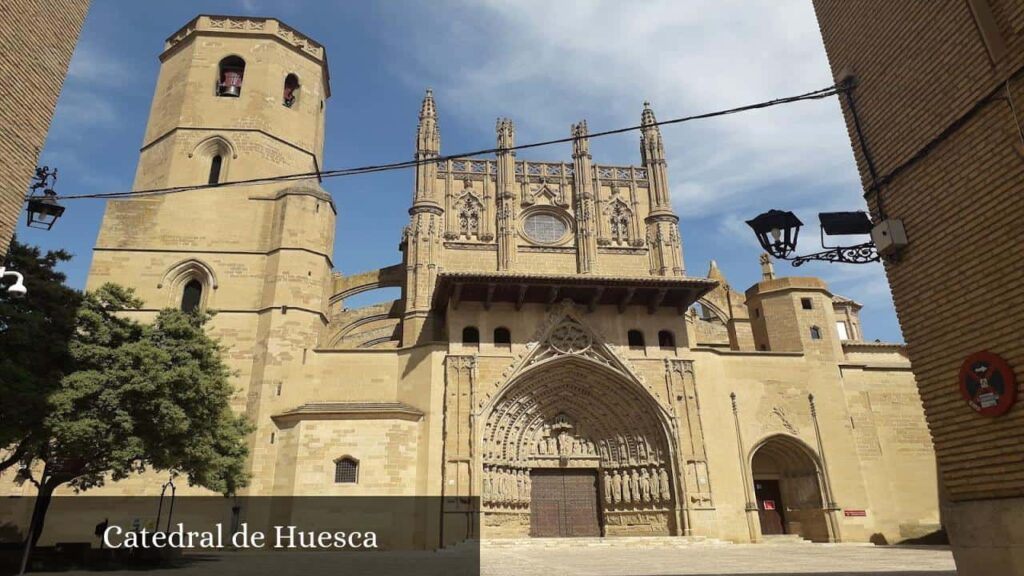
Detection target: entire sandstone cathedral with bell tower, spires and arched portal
<box><xmin>14</xmin><ymin>15</ymin><xmax>939</xmax><ymax>544</ymax></box>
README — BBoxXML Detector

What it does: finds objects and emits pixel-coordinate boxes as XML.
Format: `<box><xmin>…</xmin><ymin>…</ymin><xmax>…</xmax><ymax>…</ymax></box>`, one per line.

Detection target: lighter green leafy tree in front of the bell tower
<box><xmin>0</xmin><ymin>247</ymin><xmax>251</xmax><ymax>553</ymax></box>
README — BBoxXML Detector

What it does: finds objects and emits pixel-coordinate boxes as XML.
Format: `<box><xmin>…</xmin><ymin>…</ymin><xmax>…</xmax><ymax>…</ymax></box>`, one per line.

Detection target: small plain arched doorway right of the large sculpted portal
<box><xmin>751</xmin><ymin>435</ymin><xmax>830</xmax><ymax>542</ymax></box>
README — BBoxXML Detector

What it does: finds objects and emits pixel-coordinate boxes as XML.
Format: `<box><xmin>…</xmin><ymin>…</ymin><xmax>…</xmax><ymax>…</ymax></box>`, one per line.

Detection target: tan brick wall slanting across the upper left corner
<box><xmin>0</xmin><ymin>0</ymin><xmax>89</xmax><ymax>256</ymax></box>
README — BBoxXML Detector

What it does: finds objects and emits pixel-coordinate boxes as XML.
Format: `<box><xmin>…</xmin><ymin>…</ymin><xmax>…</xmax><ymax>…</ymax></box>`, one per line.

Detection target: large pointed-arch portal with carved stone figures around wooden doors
<box><xmin>480</xmin><ymin>356</ymin><xmax>681</xmax><ymax>537</ymax></box>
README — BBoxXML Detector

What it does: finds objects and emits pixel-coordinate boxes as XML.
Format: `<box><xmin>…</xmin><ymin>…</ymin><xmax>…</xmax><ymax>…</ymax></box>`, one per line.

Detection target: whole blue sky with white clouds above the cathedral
<box><xmin>18</xmin><ymin>0</ymin><xmax>902</xmax><ymax>341</ymax></box>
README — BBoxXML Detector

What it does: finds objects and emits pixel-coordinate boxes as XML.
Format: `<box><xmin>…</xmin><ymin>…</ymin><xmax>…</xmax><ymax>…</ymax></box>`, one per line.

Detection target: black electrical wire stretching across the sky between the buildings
<box><xmin>36</xmin><ymin>86</ymin><xmax>848</xmax><ymax>201</ymax></box>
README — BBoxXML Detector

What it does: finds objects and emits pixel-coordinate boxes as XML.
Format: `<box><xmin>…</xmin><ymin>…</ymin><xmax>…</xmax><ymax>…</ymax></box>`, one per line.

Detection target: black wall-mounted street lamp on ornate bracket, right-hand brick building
<box><xmin>746</xmin><ymin>210</ymin><xmax>888</xmax><ymax>266</ymax></box>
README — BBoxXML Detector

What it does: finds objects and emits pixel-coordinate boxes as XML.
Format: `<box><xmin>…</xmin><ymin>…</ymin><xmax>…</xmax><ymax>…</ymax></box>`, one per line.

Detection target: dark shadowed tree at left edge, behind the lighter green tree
<box><xmin>0</xmin><ymin>240</ymin><xmax>81</xmax><ymax>472</ymax></box>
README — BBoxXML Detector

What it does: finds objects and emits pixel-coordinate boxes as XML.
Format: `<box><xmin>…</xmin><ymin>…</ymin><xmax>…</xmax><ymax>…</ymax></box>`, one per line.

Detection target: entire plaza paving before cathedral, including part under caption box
<box><xmin>19</xmin><ymin>539</ymin><xmax>956</xmax><ymax>576</ymax></box>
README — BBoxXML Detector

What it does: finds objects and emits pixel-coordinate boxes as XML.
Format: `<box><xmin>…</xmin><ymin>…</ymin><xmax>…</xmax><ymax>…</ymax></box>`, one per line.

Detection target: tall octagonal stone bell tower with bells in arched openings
<box><xmin>88</xmin><ymin>15</ymin><xmax>335</xmax><ymax>494</ymax></box>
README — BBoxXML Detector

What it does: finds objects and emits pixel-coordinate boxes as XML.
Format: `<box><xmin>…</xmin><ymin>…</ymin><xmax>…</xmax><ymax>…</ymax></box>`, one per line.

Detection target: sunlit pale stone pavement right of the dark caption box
<box><xmin>480</xmin><ymin>542</ymin><xmax>956</xmax><ymax>576</ymax></box>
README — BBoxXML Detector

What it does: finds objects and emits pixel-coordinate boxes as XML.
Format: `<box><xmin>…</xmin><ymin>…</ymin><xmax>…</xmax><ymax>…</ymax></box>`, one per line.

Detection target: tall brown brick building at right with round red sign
<box><xmin>814</xmin><ymin>0</ymin><xmax>1024</xmax><ymax>575</ymax></box>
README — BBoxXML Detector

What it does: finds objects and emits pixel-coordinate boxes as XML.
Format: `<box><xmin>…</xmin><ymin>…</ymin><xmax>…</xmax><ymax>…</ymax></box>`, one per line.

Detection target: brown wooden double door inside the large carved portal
<box><xmin>529</xmin><ymin>468</ymin><xmax>601</xmax><ymax>538</ymax></box>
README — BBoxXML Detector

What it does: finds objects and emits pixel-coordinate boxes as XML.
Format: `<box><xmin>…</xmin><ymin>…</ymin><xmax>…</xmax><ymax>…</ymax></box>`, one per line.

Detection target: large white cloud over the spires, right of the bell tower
<box><xmin>391</xmin><ymin>0</ymin><xmax>860</xmax><ymax>218</ymax></box>
